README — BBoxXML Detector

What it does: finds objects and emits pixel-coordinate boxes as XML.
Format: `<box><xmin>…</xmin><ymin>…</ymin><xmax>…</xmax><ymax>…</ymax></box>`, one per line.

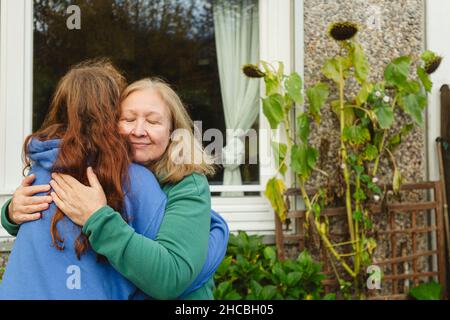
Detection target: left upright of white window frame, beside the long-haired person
<box><xmin>0</xmin><ymin>0</ymin><xmax>33</xmax><ymax>237</ymax></box>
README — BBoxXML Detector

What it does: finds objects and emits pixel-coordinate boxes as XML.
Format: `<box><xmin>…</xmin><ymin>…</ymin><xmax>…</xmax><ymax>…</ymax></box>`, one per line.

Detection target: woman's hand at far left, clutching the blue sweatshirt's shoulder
<box><xmin>8</xmin><ymin>174</ymin><xmax>52</xmax><ymax>225</ymax></box>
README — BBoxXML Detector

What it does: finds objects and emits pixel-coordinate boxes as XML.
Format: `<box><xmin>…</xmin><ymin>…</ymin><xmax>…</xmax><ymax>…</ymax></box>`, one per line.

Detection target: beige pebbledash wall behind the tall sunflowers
<box><xmin>304</xmin><ymin>0</ymin><xmax>426</xmax><ymax>188</ymax></box>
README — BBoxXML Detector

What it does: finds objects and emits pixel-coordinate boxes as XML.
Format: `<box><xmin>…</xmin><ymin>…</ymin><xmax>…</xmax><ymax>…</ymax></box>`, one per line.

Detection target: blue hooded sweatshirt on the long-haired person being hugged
<box><xmin>0</xmin><ymin>139</ymin><xmax>228</xmax><ymax>300</ymax></box>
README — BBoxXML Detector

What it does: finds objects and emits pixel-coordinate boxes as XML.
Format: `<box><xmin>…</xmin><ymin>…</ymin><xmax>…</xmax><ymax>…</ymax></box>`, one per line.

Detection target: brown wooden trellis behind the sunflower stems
<box><xmin>275</xmin><ymin>181</ymin><xmax>447</xmax><ymax>299</ymax></box>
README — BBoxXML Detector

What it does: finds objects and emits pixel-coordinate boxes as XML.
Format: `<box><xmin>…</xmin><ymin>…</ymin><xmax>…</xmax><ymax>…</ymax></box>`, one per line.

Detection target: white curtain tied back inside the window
<box><xmin>213</xmin><ymin>0</ymin><xmax>259</xmax><ymax>196</ymax></box>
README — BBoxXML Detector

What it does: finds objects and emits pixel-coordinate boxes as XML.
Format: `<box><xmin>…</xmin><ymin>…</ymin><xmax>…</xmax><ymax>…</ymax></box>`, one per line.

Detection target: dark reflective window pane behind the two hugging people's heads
<box><xmin>33</xmin><ymin>0</ymin><xmax>259</xmax><ymax>184</ymax></box>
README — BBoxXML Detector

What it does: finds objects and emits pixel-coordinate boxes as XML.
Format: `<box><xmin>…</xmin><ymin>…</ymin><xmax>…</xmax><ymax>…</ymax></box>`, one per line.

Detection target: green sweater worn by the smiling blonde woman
<box><xmin>1</xmin><ymin>173</ymin><xmax>214</xmax><ymax>300</ymax></box>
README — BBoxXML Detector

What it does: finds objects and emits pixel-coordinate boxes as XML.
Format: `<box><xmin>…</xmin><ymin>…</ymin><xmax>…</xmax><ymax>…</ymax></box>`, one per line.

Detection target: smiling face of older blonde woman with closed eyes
<box><xmin>119</xmin><ymin>89</ymin><xmax>171</xmax><ymax>164</ymax></box>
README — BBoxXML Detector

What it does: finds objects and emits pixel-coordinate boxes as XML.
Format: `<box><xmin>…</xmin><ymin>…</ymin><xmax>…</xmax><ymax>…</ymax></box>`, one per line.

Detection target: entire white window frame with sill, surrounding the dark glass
<box><xmin>0</xmin><ymin>0</ymin><xmax>302</xmax><ymax>237</ymax></box>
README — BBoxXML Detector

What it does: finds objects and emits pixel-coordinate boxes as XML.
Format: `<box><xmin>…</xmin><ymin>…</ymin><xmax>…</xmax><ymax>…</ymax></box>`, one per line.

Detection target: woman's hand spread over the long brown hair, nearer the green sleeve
<box><xmin>50</xmin><ymin>167</ymin><xmax>107</xmax><ymax>226</ymax></box>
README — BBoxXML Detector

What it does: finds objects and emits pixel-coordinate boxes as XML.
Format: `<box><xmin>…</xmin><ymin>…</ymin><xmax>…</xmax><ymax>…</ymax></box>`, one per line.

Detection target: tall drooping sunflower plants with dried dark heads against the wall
<box><xmin>243</xmin><ymin>22</ymin><xmax>442</xmax><ymax>294</ymax></box>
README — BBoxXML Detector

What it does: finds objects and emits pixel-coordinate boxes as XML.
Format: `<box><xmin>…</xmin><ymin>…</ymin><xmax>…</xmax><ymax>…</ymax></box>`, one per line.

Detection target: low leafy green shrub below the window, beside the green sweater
<box><xmin>214</xmin><ymin>231</ymin><xmax>335</xmax><ymax>300</ymax></box>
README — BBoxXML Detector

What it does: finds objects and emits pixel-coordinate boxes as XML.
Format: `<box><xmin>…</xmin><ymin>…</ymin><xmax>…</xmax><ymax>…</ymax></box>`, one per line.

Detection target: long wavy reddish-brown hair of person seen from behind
<box><xmin>24</xmin><ymin>59</ymin><xmax>132</xmax><ymax>259</ymax></box>
